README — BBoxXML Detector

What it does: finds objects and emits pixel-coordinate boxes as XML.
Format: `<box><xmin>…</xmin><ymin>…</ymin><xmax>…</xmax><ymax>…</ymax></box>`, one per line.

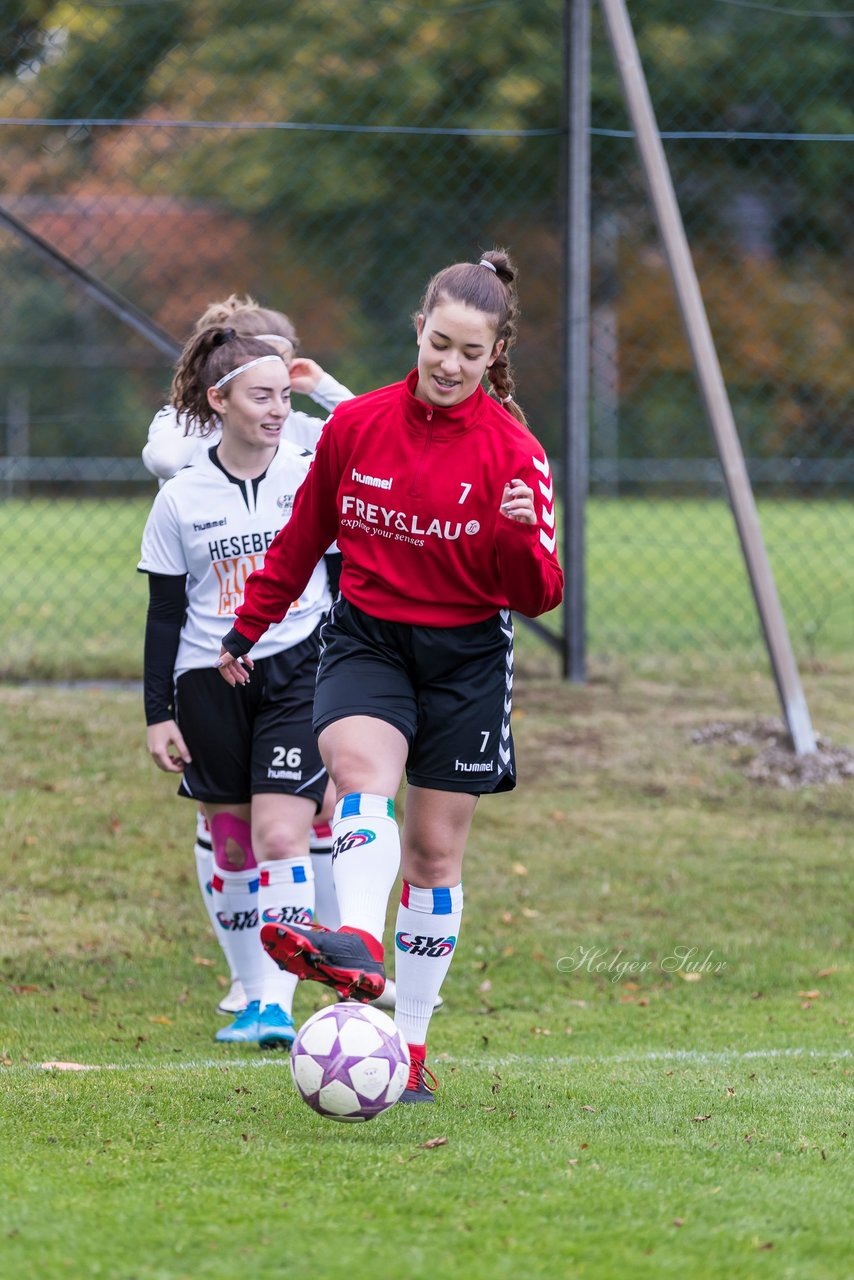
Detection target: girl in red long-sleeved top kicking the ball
<box><xmin>219</xmin><ymin>250</ymin><xmax>563</xmax><ymax>1102</ymax></box>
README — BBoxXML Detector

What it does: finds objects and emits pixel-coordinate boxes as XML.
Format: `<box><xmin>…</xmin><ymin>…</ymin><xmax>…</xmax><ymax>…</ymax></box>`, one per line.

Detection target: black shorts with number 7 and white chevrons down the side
<box><xmin>314</xmin><ymin>598</ymin><xmax>516</xmax><ymax>795</ymax></box>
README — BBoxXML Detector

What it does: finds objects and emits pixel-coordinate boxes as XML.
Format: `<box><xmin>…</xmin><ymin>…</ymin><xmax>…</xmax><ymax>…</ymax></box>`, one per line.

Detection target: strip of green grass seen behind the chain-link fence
<box><xmin>0</xmin><ymin>499</ymin><xmax>854</xmax><ymax>680</ymax></box>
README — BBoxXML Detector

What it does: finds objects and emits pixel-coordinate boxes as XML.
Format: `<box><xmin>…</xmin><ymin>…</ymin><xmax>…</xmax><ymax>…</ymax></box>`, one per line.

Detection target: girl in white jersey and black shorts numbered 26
<box><xmin>140</xmin><ymin>328</ymin><xmax>330</xmax><ymax>1047</ymax></box>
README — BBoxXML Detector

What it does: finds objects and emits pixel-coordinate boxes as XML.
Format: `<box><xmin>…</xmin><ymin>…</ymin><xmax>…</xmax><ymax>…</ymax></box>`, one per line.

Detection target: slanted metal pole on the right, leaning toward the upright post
<box><xmin>599</xmin><ymin>0</ymin><xmax>816</xmax><ymax>755</ymax></box>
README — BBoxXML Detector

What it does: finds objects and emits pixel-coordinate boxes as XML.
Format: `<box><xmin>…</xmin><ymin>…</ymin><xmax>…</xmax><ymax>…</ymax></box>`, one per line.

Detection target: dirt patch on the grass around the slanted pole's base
<box><xmin>690</xmin><ymin>718</ymin><xmax>854</xmax><ymax>791</ymax></box>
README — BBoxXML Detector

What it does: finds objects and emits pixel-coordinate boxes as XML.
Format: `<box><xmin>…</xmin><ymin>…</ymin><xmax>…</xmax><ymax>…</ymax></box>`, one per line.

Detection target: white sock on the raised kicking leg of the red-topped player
<box><xmin>332</xmin><ymin>791</ymin><xmax>401</xmax><ymax>942</ymax></box>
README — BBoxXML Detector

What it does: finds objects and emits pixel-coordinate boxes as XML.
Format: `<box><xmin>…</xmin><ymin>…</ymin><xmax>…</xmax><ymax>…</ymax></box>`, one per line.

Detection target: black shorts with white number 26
<box><xmin>175</xmin><ymin>627</ymin><xmax>326</xmax><ymax>808</ymax></box>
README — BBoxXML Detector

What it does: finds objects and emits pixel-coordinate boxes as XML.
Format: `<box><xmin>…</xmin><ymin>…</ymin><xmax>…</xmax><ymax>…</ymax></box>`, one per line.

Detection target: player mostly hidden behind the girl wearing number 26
<box><xmin>142</xmin><ymin>293</ymin><xmax>353</xmax><ymax>1015</ymax></box>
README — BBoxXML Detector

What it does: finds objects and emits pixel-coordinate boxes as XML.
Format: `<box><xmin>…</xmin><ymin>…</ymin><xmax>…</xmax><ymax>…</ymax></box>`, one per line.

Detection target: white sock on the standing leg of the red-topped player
<box><xmin>394</xmin><ymin>881</ymin><xmax>462</xmax><ymax>1044</ymax></box>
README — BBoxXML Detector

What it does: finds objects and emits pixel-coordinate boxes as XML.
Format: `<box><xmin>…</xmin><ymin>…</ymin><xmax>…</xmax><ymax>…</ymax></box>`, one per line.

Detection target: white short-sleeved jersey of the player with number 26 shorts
<box><xmin>138</xmin><ymin>440</ymin><xmax>332</xmax><ymax>680</ymax></box>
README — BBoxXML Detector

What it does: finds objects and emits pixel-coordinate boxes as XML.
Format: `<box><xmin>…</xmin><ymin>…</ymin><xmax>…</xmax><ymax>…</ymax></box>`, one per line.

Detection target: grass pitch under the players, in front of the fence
<box><xmin>0</xmin><ymin>660</ymin><xmax>854</xmax><ymax>1280</ymax></box>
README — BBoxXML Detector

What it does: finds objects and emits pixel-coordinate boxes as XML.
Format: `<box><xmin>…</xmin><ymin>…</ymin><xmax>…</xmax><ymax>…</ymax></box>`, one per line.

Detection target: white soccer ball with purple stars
<box><xmin>291</xmin><ymin>1004</ymin><xmax>410</xmax><ymax>1120</ymax></box>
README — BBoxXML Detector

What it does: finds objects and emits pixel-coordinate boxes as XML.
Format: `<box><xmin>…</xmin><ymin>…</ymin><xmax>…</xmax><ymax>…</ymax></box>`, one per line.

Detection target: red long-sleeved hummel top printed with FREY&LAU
<box><xmin>229</xmin><ymin>371</ymin><xmax>563</xmax><ymax>644</ymax></box>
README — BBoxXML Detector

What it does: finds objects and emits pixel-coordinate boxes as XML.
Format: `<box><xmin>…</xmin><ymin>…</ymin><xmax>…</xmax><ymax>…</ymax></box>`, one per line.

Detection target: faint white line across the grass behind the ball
<box><xmin>0</xmin><ymin>1048</ymin><xmax>854</xmax><ymax>1076</ymax></box>
